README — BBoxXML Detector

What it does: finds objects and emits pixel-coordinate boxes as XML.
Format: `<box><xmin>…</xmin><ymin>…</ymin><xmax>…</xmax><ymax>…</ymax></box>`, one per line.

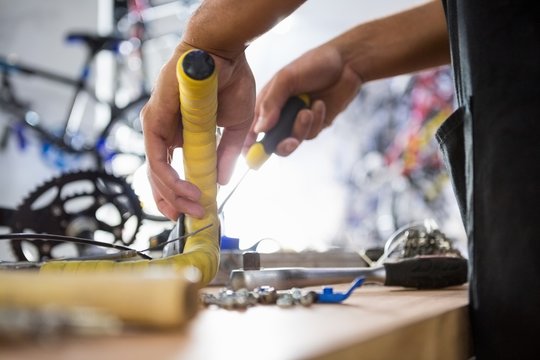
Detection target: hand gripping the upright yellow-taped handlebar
<box><xmin>141</xmin><ymin>44</ymin><xmax>255</xmax><ymax>220</ymax></box>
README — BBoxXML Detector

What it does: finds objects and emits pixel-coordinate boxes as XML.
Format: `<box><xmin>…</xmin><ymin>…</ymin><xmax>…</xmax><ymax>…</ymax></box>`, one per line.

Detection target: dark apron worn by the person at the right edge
<box><xmin>437</xmin><ymin>0</ymin><xmax>540</xmax><ymax>360</ymax></box>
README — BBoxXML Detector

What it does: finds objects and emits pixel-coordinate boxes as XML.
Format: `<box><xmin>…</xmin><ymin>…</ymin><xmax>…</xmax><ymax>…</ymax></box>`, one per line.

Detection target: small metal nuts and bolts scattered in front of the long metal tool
<box><xmin>201</xmin><ymin>286</ymin><xmax>318</xmax><ymax>310</ymax></box>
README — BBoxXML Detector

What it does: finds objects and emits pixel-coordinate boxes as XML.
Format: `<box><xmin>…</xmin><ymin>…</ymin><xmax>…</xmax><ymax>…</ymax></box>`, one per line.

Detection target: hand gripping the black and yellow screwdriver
<box><xmin>244</xmin><ymin>41</ymin><xmax>362</xmax><ymax>156</ymax></box>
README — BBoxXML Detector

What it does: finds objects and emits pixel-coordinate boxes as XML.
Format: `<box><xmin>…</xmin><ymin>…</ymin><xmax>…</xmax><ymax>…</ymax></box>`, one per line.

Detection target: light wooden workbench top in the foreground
<box><xmin>0</xmin><ymin>285</ymin><xmax>471</xmax><ymax>360</ymax></box>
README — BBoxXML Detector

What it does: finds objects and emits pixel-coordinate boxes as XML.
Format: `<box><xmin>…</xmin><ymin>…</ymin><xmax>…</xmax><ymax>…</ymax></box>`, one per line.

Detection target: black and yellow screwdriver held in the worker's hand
<box><xmin>218</xmin><ymin>94</ymin><xmax>311</xmax><ymax>214</ymax></box>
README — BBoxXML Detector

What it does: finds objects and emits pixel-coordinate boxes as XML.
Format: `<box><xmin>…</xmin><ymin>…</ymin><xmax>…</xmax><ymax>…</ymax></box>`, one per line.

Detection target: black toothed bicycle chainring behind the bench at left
<box><xmin>11</xmin><ymin>171</ymin><xmax>143</xmax><ymax>261</ymax></box>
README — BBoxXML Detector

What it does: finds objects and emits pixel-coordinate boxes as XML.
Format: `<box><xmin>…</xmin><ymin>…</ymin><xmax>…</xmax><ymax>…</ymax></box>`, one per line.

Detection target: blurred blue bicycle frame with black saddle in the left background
<box><xmin>0</xmin><ymin>33</ymin><xmax>149</xmax><ymax>170</ymax></box>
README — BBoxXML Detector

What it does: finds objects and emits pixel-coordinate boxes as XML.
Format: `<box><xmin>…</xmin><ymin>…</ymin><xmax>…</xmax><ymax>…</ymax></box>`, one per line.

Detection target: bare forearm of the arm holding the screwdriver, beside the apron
<box><xmin>332</xmin><ymin>1</ymin><xmax>450</xmax><ymax>82</ymax></box>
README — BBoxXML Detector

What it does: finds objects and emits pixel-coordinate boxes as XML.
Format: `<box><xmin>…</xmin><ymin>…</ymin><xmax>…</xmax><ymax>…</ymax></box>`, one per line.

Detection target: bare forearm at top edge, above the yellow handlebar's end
<box><xmin>182</xmin><ymin>0</ymin><xmax>305</xmax><ymax>59</ymax></box>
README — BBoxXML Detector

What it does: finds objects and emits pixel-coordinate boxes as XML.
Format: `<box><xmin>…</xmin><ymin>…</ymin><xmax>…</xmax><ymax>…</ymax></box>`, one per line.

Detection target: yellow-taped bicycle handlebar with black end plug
<box><xmin>40</xmin><ymin>50</ymin><xmax>220</xmax><ymax>286</ymax></box>
